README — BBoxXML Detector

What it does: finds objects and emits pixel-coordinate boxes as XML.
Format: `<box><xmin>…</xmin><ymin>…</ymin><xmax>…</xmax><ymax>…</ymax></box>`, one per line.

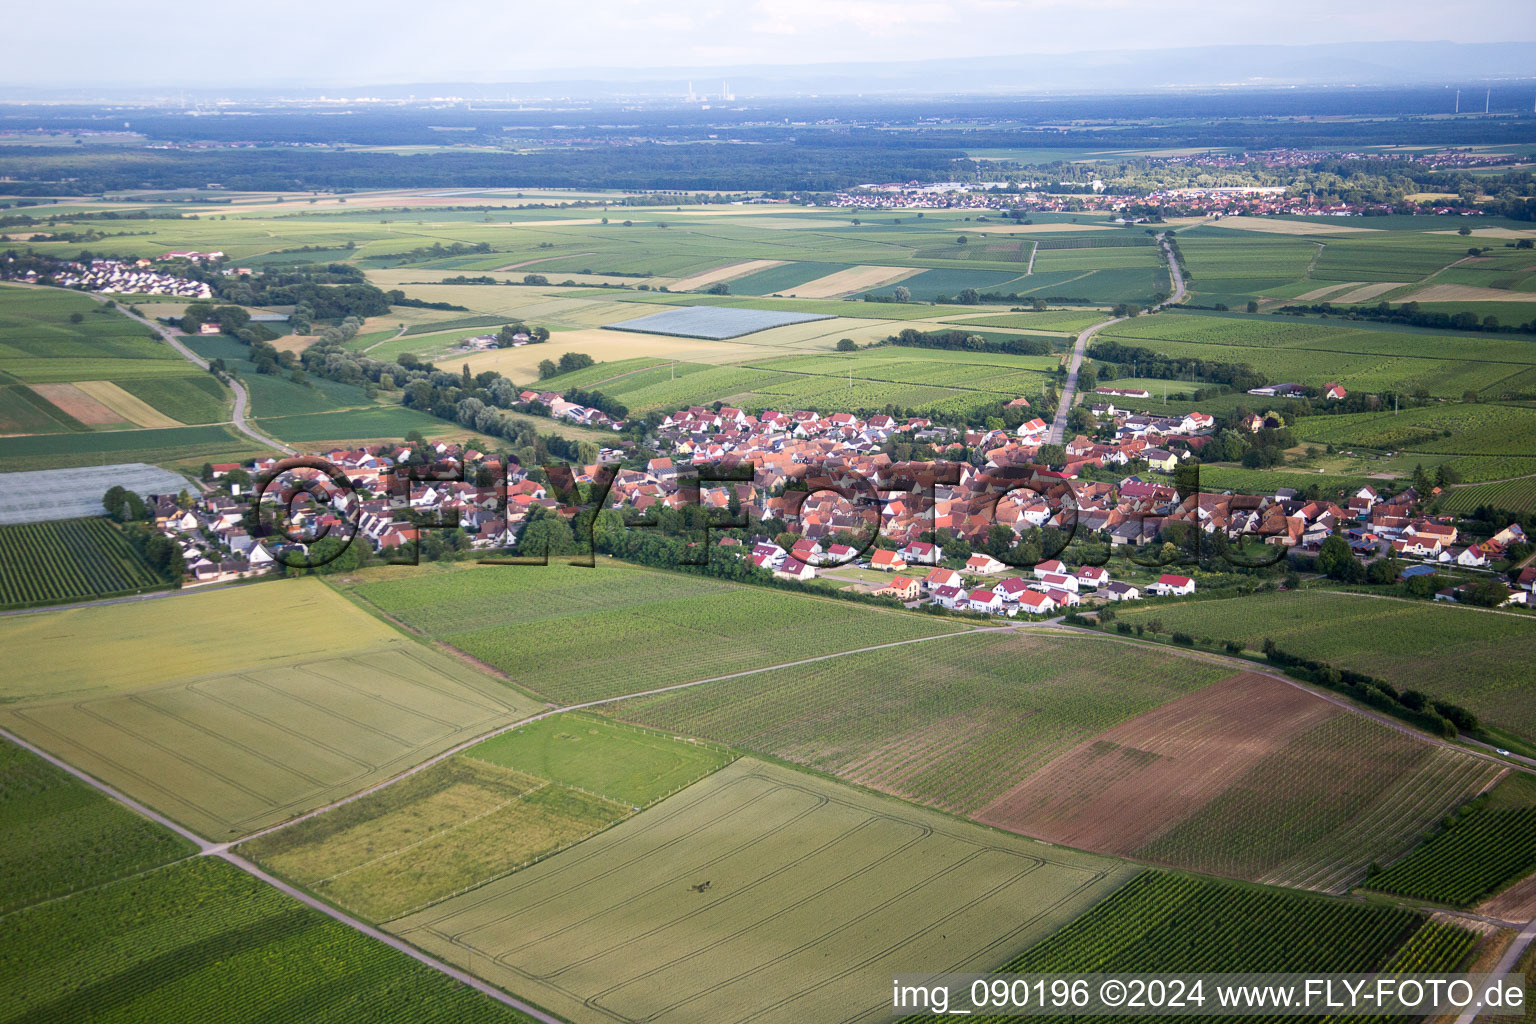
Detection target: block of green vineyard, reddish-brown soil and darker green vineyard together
<box><xmin>611</xmin><ymin>634</ymin><xmax>1498</xmax><ymax>892</ymax></box>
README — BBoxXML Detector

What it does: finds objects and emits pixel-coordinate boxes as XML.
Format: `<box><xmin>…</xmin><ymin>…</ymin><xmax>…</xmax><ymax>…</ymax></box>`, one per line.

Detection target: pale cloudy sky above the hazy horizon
<box><xmin>9</xmin><ymin>0</ymin><xmax>1536</xmax><ymax>88</ymax></box>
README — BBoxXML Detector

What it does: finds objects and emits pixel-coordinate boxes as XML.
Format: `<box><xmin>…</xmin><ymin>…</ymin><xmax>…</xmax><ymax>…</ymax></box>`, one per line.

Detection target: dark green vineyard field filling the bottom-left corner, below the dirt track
<box><xmin>0</xmin><ymin>858</ymin><xmax>528</xmax><ymax>1024</ymax></box>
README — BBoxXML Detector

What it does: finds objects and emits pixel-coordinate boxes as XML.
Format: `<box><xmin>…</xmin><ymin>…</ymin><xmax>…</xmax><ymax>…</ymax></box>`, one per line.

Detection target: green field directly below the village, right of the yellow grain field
<box><xmin>342</xmin><ymin>560</ymin><xmax>965</xmax><ymax>703</ymax></box>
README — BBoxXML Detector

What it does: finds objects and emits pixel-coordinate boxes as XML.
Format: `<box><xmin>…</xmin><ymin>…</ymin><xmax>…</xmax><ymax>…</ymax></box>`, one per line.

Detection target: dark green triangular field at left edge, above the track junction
<box><xmin>0</xmin><ymin>740</ymin><xmax>194</xmax><ymax>915</ymax></box>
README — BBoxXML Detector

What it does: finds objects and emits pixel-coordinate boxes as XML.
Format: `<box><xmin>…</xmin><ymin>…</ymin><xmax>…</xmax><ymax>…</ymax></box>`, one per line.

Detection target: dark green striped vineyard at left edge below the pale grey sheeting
<box><xmin>0</xmin><ymin>517</ymin><xmax>167</xmax><ymax>608</ymax></box>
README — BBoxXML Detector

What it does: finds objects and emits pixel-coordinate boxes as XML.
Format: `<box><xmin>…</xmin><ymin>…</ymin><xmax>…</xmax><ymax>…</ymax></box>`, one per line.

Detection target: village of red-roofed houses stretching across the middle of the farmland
<box><xmin>135</xmin><ymin>388</ymin><xmax>1536</xmax><ymax>617</ymax></box>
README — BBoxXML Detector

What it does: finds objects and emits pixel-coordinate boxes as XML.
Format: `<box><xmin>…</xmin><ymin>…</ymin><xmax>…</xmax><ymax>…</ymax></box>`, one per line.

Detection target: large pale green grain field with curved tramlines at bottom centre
<box><xmin>390</xmin><ymin>758</ymin><xmax>1130</xmax><ymax>1024</ymax></box>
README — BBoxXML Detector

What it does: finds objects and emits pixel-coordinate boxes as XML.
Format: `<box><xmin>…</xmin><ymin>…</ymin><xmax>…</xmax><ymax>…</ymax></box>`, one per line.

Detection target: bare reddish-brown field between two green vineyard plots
<box><xmin>975</xmin><ymin>672</ymin><xmax>1336</xmax><ymax>855</ymax></box>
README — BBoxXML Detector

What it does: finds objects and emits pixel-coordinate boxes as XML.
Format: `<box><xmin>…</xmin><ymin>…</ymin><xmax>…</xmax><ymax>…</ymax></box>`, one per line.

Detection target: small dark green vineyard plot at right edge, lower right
<box><xmin>1366</xmin><ymin>808</ymin><xmax>1536</xmax><ymax>907</ymax></box>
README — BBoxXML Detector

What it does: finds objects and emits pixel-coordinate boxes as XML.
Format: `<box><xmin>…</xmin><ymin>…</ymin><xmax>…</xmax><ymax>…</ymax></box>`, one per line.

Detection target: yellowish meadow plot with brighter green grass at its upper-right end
<box><xmin>241</xmin><ymin>714</ymin><xmax>731</xmax><ymax>921</ymax></box>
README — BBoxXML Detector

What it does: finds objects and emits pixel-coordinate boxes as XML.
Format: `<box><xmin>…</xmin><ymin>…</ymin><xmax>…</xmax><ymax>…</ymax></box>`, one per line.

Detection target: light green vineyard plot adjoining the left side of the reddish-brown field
<box><xmin>613</xmin><ymin>634</ymin><xmax>1227</xmax><ymax>810</ymax></box>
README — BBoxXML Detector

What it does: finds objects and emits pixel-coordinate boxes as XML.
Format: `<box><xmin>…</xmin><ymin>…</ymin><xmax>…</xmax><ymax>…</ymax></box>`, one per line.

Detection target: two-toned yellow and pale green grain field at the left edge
<box><xmin>0</xmin><ymin>580</ymin><xmax>538</xmax><ymax>838</ymax></box>
